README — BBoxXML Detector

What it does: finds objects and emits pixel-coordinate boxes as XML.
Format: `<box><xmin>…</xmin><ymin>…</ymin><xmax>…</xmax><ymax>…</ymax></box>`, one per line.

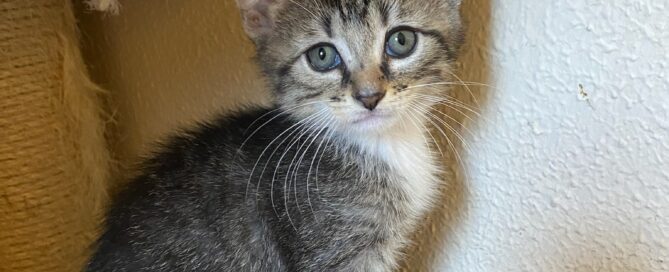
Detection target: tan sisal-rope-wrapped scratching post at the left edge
<box><xmin>0</xmin><ymin>0</ymin><xmax>110</xmax><ymax>272</ymax></box>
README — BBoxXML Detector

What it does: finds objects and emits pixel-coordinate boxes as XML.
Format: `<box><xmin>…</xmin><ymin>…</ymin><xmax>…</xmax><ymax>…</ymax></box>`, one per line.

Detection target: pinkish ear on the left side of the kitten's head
<box><xmin>237</xmin><ymin>0</ymin><xmax>288</xmax><ymax>41</ymax></box>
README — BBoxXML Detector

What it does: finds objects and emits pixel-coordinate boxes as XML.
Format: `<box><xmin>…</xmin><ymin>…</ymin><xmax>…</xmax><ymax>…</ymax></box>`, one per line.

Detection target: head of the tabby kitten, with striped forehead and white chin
<box><xmin>237</xmin><ymin>0</ymin><xmax>462</xmax><ymax>136</ymax></box>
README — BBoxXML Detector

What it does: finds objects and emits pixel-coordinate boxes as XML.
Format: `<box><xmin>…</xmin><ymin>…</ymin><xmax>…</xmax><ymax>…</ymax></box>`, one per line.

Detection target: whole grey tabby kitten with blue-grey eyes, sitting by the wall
<box><xmin>88</xmin><ymin>0</ymin><xmax>462</xmax><ymax>272</ymax></box>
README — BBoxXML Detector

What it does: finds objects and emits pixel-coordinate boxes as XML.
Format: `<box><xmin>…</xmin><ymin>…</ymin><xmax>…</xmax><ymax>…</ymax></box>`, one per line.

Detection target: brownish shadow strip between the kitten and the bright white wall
<box><xmin>401</xmin><ymin>0</ymin><xmax>492</xmax><ymax>271</ymax></box>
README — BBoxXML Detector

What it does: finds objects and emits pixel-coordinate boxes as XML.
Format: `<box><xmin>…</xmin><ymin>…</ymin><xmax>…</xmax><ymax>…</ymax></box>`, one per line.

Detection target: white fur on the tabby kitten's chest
<box><xmin>344</xmin><ymin>126</ymin><xmax>439</xmax><ymax>271</ymax></box>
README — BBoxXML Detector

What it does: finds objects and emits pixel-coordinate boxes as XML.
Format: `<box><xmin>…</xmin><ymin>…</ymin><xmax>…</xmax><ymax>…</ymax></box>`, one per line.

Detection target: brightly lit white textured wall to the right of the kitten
<box><xmin>440</xmin><ymin>0</ymin><xmax>669</xmax><ymax>272</ymax></box>
